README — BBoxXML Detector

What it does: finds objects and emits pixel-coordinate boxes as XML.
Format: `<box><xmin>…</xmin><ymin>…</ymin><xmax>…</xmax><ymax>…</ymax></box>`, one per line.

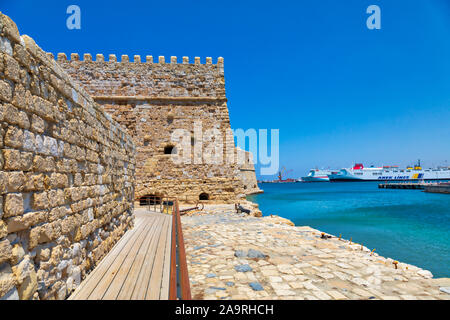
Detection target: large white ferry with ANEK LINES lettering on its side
<box><xmin>329</xmin><ymin>162</ymin><xmax>450</xmax><ymax>181</ymax></box>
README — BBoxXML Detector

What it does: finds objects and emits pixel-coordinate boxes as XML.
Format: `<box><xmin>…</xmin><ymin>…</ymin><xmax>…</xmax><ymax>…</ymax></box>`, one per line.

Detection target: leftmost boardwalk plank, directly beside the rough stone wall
<box><xmin>69</xmin><ymin>220</ymin><xmax>148</xmax><ymax>300</ymax></box>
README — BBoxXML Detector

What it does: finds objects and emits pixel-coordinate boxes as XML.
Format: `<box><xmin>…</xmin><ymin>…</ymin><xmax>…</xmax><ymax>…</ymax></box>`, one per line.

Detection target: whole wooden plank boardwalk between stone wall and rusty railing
<box><xmin>69</xmin><ymin>210</ymin><xmax>172</xmax><ymax>300</ymax></box>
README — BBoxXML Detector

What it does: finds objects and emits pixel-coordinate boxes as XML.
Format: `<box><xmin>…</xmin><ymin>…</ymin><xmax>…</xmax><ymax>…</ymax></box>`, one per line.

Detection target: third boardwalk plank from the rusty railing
<box><xmin>131</xmin><ymin>214</ymin><xmax>164</xmax><ymax>300</ymax></box>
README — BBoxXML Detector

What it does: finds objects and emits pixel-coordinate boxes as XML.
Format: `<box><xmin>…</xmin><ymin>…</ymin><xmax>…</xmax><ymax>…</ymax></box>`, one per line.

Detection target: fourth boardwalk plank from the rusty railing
<box><xmin>116</xmin><ymin>217</ymin><xmax>162</xmax><ymax>300</ymax></box>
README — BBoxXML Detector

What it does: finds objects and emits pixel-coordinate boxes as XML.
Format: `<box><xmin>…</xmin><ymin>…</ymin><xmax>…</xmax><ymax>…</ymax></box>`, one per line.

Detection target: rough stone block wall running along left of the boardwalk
<box><xmin>0</xmin><ymin>13</ymin><xmax>135</xmax><ymax>300</ymax></box>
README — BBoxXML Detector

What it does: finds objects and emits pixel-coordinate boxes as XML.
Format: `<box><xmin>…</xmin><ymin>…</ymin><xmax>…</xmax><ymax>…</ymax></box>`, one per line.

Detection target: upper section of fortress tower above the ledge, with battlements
<box><xmin>59</xmin><ymin>53</ymin><xmax>226</xmax><ymax>102</ymax></box>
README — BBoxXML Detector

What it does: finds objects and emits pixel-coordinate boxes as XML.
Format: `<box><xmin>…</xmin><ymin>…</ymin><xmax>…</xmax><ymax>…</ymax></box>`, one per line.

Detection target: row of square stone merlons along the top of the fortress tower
<box><xmin>51</xmin><ymin>52</ymin><xmax>223</xmax><ymax>66</ymax></box>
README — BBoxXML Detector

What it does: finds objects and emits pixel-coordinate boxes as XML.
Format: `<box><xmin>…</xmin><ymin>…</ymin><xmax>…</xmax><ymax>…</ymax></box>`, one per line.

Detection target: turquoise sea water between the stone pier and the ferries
<box><xmin>248</xmin><ymin>182</ymin><xmax>450</xmax><ymax>277</ymax></box>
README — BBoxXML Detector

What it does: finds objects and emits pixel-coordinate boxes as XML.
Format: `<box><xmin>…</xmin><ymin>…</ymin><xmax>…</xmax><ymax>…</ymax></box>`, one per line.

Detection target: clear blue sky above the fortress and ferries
<box><xmin>0</xmin><ymin>0</ymin><xmax>450</xmax><ymax>178</ymax></box>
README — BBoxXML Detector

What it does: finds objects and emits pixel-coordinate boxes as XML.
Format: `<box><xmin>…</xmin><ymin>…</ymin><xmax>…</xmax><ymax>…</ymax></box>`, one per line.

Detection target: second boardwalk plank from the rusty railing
<box><xmin>145</xmin><ymin>215</ymin><xmax>169</xmax><ymax>300</ymax></box>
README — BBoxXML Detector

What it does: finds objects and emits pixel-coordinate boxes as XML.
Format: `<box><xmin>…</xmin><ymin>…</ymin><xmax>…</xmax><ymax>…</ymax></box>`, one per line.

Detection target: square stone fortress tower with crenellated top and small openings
<box><xmin>57</xmin><ymin>53</ymin><xmax>256</xmax><ymax>202</ymax></box>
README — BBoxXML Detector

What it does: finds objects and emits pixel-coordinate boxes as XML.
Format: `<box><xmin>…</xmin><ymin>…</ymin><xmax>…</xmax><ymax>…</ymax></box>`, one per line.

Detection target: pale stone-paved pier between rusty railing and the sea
<box><xmin>182</xmin><ymin>205</ymin><xmax>450</xmax><ymax>300</ymax></box>
